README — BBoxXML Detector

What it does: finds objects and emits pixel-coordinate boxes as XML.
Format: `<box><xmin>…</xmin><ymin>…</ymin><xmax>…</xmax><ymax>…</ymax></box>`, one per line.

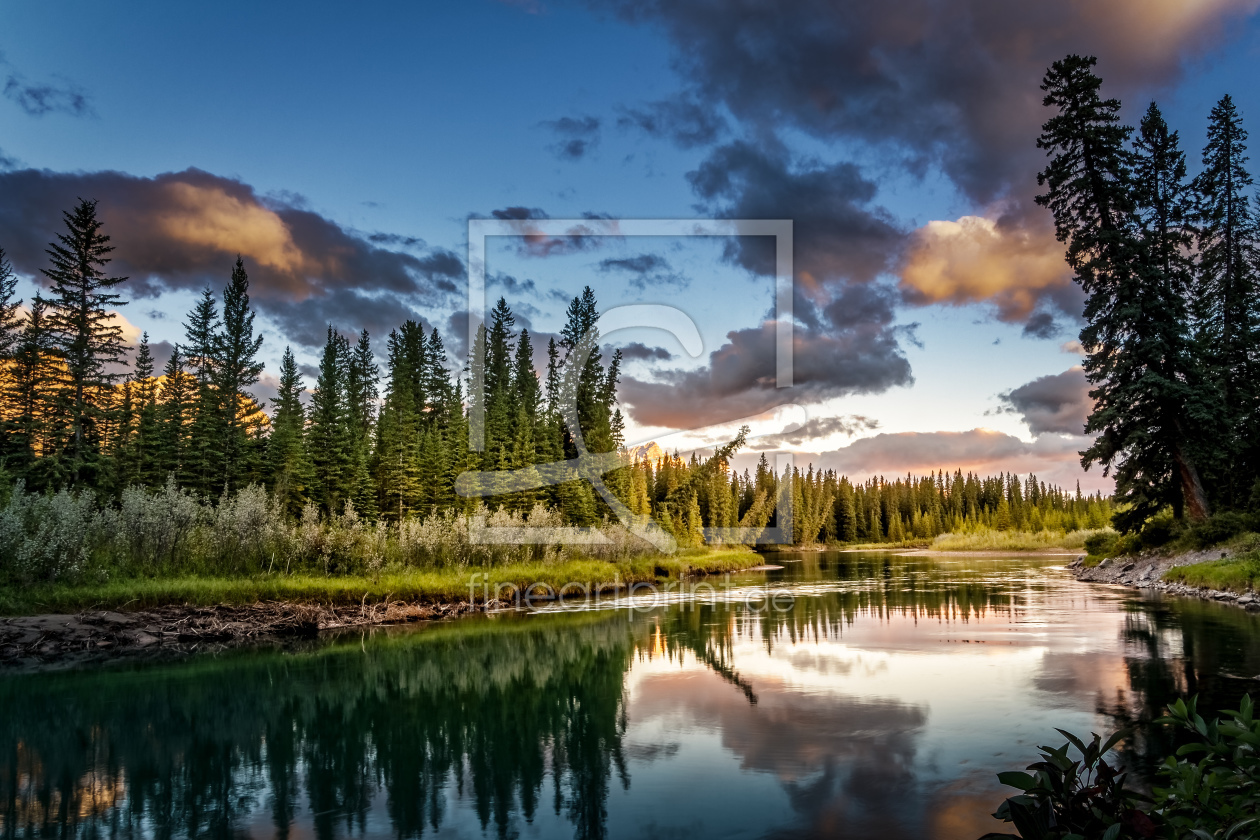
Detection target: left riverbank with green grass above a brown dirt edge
<box><xmin>0</xmin><ymin>548</ymin><xmax>765</xmax><ymax>669</ymax></box>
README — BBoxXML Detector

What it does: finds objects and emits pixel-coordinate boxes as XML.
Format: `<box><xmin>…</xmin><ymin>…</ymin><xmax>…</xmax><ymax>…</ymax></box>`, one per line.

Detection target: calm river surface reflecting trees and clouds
<box><xmin>0</xmin><ymin>553</ymin><xmax>1260</xmax><ymax>840</ymax></box>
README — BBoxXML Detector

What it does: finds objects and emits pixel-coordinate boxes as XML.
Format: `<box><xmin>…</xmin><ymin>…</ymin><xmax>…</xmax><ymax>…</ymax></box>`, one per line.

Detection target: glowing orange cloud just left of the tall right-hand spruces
<box><xmin>901</xmin><ymin>215</ymin><xmax>1080</xmax><ymax>324</ymax></box>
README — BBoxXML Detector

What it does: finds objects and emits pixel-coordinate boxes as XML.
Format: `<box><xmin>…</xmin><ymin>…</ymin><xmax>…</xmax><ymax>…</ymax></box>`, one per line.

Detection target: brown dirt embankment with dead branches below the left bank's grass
<box><xmin>0</xmin><ymin>601</ymin><xmax>483</xmax><ymax>673</ymax></box>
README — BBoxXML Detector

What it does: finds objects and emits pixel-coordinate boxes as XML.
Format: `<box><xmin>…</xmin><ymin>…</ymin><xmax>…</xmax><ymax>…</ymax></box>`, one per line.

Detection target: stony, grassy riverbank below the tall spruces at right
<box><xmin>1067</xmin><ymin>547</ymin><xmax>1260</xmax><ymax>611</ymax></box>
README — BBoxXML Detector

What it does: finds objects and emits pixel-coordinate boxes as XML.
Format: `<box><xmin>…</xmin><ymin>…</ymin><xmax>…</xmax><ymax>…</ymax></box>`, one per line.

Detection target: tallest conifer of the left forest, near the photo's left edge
<box><xmin>43</xmin><ymin>200</ymin><xmax>126</xmax><ymax>485</ymax></box>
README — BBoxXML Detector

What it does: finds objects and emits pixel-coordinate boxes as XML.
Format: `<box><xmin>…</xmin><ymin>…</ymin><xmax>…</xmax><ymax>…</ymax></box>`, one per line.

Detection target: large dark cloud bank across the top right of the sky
<box><xmin>591</xmin><ymin>0</ymin><xmax>1257</xmax><ymax>203</ymax></box>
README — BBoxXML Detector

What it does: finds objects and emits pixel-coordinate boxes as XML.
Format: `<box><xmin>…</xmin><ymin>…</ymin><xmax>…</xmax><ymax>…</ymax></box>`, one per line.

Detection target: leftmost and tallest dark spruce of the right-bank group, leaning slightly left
<box><xmin>1037</xmin><ymin>55</ymin><xmax>1208</xmax><ymax>528</ymax></box>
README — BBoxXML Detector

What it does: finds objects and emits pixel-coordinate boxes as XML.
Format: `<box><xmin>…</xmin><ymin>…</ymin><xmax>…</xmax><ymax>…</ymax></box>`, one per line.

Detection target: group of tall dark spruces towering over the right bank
<box><xmin>1037</xmin><ymin>55</ymin><xmax>1260</xmax><ymax>530</ymax></box>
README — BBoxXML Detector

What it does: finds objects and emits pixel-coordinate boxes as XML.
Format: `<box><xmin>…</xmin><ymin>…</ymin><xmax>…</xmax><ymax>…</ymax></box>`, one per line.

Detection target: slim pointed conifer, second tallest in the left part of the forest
<box><xmin>212</xmin><ymin>256</ymin><xmax>263</xmax><ymax>491</ymax></box>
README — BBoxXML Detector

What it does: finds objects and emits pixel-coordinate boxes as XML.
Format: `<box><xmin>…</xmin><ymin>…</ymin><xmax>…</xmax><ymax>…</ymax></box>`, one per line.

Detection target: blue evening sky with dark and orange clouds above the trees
<box><xmin>0</xmin><ymin>0</ymin><xmax>1260</xmax><ymax>490</ymax></box>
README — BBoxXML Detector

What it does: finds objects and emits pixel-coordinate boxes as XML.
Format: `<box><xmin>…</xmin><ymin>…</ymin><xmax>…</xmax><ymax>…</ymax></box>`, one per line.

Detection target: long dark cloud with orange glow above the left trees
<box><xmin>0</xmin><ymin>169</ymin><xmax>464</xmax><ymax>344</ymax></box>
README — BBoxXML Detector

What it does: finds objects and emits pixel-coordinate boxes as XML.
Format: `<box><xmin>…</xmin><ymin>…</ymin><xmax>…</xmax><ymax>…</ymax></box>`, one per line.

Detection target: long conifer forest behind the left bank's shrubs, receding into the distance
<box><xmin>0</xmin><ymin>201</ymin><xmax>1110</xmax><ymax>559</ymax></box>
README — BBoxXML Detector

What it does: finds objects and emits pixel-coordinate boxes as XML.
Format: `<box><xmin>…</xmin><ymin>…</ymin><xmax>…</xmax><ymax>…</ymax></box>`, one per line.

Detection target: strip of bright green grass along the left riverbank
<box><xmin>0</xmin><ymin>548</ymin><xmax>764</xmax><ymax>616</ymax></box>
